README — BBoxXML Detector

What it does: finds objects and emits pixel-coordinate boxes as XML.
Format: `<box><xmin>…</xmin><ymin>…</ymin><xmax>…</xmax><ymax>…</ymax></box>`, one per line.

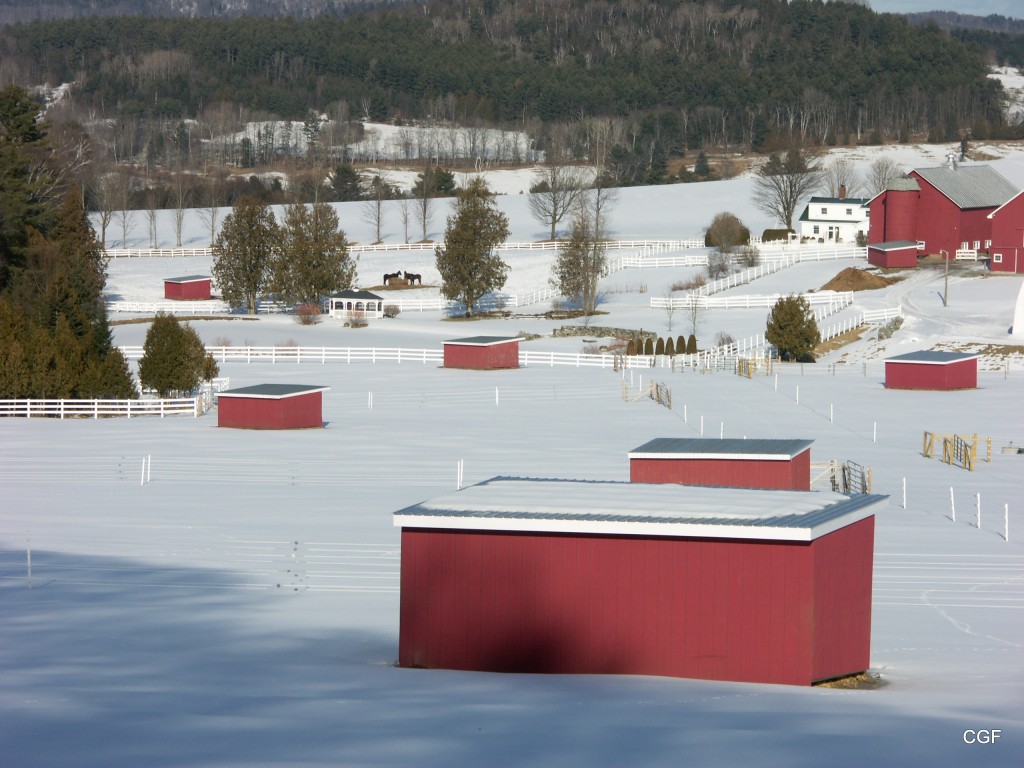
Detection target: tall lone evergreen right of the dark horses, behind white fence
<box><xmin>434</xmin><ymin>177</ymin><xmax>509</xmax><ymax>316</ymax></box>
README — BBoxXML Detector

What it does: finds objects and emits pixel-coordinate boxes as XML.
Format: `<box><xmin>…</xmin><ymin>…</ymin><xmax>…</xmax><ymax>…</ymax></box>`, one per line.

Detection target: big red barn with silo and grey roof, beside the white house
<box><xmin>868</xmin><ymin>162</ymin><xmax>1018</xmax><ymax>258</ymax></box>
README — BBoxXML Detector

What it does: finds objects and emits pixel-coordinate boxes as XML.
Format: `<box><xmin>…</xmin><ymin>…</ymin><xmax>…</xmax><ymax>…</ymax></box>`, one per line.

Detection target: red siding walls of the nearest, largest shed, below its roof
<box><xmin>398</xmin><ymin>528</ymin><xmax>871</xmax><ymax>685</ymax></box>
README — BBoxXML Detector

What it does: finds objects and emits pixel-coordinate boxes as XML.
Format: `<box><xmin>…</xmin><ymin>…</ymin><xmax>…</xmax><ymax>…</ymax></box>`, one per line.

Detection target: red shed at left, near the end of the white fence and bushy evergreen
<box><xmin>217</xmin><ymin>384</ymin><xmax>330</xmax><ymax>429</ymax></box>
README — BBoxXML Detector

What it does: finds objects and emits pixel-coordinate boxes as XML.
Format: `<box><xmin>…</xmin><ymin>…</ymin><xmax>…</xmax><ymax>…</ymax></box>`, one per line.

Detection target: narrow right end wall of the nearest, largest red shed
<box><xmin>811</xmin><ymin>517</ymin><xmax>874</xmax><ymax>681</ymax></box>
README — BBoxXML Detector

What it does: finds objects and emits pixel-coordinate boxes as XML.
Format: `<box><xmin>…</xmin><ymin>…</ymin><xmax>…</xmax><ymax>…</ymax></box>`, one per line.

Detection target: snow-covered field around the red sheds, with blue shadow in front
<box><xmin>0</xmin><ymin>141</ymin><xmax>1024</xmax><ymax>768</ymax></box>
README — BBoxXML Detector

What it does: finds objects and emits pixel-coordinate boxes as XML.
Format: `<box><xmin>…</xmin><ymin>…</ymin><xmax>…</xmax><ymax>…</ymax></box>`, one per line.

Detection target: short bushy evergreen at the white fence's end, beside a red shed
<box><xmin>138</xmin><ymin>312</ymin><xmax>218</xmax><ymax>397</ymax></box>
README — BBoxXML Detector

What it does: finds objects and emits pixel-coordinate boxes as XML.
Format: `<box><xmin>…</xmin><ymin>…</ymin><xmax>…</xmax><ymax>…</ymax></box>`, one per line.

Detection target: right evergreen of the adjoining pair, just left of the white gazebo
<box><xmin>270</xmin><ymin>203</ymin><xmax>355</xmax><ymax>305</ymax></box>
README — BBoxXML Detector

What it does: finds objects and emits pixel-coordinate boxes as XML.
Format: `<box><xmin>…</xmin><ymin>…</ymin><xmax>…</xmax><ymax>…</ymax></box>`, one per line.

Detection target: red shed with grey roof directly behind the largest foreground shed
<box><xmin>629</xmin><ymin>437</ymin><xmax>813</xmax><ymax>490</ymax></box>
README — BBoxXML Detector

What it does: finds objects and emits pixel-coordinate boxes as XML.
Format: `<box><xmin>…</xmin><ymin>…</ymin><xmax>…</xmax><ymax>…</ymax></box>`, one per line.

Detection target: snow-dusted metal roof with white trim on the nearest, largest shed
<box><xmin>394</xmin><ymin>477</ymin><xmax>889</xmax><ymax>542</ymax></box>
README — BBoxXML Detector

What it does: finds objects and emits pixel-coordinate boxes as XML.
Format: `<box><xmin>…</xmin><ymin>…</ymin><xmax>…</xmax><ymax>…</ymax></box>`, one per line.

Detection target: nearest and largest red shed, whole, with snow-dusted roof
<box><xmin>394</xmin><ymin>478</ymin><xmax>886</xmax><ymax>685</ymax></box>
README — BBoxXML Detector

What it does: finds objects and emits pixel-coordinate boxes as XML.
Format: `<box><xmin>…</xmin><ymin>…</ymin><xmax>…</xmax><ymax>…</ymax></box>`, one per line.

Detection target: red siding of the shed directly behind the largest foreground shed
<box><xmin>630</xmin><ymin>449</ymin><xmax>811</xmax><ymax>490</ymax></box>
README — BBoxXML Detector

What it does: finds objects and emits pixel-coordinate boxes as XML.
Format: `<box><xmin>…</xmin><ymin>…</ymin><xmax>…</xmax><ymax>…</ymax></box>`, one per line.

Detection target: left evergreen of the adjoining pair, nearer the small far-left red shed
<box><xmin>213</xmin><ymin>196</ymin><xmax>280</xmax><ymax>314</ymax></box>
